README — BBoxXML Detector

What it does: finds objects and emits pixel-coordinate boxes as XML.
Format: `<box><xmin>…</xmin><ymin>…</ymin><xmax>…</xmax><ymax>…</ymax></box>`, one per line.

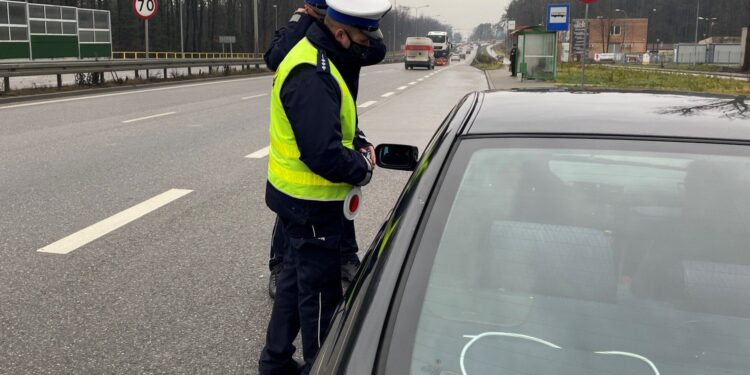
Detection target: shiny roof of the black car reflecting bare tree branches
<box><xmin>470</xmin><ymin>89</ymin><xmax>750</xmax><ymax>141</ymax></box>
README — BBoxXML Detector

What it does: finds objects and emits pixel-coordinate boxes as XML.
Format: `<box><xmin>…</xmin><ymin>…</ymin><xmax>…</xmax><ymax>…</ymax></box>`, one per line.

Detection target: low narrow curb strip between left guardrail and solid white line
<box><xmin>0</xmin><ymin>72</ymin><xmax>273</xmax><ymax>105</ymax></box>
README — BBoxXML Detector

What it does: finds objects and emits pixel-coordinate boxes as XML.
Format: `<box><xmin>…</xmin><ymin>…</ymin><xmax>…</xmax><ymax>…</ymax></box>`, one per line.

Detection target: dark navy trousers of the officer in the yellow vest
<box><xmin>260</xmin><ymin>209</ymin><xmax>349</xmax><ymax>375</ymax></box>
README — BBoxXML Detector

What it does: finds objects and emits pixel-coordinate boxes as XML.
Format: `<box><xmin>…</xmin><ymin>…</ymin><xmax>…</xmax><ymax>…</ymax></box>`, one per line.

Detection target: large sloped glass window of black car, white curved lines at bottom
<box><xmin>406</xmin><ymin>139</ymin><xmax>750</xmax><ymax>375</ymax></box>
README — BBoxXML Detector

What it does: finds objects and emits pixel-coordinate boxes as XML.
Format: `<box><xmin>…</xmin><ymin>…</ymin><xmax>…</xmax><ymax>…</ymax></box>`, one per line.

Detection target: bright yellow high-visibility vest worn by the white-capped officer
<box><xmin>268</xmin><ymin>38</ymin><xmax>357</xmax><ymax>201</ymax></box>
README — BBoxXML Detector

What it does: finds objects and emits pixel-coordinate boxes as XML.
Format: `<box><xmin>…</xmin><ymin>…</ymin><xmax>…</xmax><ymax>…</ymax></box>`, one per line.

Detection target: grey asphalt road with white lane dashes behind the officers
<box><xmin>0</xmin><ymin>54</ymin><xmax>486</xmax><ymax>374</ymax></box>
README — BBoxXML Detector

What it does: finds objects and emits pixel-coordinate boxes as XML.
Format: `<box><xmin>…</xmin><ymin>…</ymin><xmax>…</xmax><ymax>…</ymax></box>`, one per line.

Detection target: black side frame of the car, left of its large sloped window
<box><xmin>311</xmin><ymin>93</ymin><xmax>483</xmax><ymax>374</ymax></box>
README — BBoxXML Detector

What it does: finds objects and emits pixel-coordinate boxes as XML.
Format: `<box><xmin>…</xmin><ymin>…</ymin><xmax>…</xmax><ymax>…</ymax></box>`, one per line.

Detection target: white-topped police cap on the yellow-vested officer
<box><xmin>326</xmin><ymin>0</ymin><xmax>393</xmax><ymax>39</ymax></box>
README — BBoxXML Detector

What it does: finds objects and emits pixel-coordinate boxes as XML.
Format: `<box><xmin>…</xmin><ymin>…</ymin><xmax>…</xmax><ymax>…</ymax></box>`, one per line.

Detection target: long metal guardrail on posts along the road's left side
<box><xmin>0</xmin><ymin>58</ymin><xmax>265</xmax><ymax>92</ymax></box>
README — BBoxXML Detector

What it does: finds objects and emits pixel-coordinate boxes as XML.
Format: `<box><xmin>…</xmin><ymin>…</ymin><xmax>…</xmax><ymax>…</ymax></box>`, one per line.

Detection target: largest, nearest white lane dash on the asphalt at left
<box><xmin>37</xmin><ymin>189</ymin><xmax>193</xmax><ymax>254</ymax></box>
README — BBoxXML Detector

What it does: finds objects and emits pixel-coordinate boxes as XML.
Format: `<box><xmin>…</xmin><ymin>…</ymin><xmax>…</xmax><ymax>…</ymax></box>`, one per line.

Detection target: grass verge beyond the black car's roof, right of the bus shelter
<box><xmin>556</xmin><ymin>64</ymin><xmax>750</xmax><ymax>95</ymax></box>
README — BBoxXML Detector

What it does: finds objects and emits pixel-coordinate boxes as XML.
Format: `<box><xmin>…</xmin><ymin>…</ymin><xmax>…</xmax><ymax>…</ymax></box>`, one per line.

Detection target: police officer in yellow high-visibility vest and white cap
<box><xmin>259</xmin><ymin>0</ymin><xmax>391</xmax><ymax>374</ymax></box>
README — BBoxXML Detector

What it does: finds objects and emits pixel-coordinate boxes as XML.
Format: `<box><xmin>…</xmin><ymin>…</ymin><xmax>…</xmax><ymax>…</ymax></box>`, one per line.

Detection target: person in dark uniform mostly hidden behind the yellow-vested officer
<box><xmin>263</xmin><ymin>0</ymin><xmax>386</xmax><ymax>298</ymax></box>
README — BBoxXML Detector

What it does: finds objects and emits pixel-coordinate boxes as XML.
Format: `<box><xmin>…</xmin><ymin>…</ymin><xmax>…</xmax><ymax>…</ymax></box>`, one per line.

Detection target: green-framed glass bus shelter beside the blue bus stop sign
<box><xmin>513</xmin><ymin>26</ymin><xmax>557</xmax><ymax>80</ymax></box>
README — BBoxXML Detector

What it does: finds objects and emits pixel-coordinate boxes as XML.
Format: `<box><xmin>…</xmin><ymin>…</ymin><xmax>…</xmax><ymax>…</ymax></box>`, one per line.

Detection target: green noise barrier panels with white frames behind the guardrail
<box><xmin>0</xmin><ymin>0</ymin><xmax>112</xmax><ymax>61</ymax></box>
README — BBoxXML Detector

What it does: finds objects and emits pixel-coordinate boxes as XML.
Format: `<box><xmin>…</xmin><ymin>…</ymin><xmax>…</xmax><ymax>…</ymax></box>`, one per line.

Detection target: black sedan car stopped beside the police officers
<box><xmin>313</xmin><ymin>92</ymin><xmax>750</xmax><ymax>375</ymax></box>
